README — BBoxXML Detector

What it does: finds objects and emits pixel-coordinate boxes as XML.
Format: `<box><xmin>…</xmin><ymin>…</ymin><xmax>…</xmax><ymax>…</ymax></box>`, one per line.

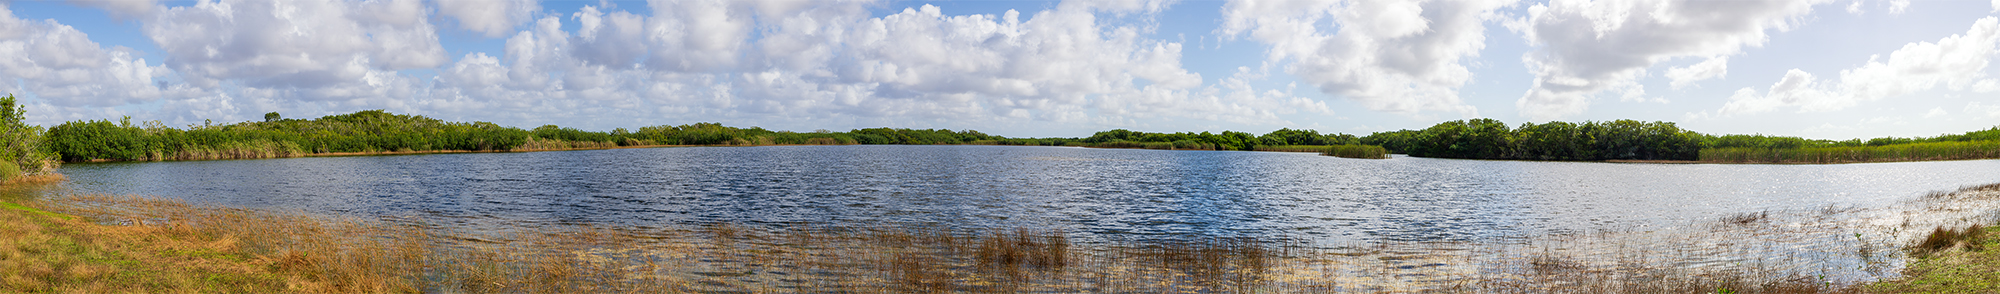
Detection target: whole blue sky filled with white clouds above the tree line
<box><xmin>11</xmin><ymin>0</ymin><xmax>2000</xmax><ymax>140</ymax></box>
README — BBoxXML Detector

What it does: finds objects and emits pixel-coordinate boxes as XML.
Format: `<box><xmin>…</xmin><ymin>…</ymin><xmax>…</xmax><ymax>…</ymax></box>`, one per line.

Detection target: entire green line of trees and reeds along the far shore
<box><xmin>27</xmin><ymin>107</ymin><xmax>2000</xmax><ymax>164</ymax></box>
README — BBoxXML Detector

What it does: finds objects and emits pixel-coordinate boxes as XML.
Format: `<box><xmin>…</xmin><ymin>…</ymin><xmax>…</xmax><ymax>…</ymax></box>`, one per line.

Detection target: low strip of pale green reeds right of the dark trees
<box><xmin>1700</xmin><ymin>140</ymin><xmax>2000</xmax><ymax>164</ymax></box>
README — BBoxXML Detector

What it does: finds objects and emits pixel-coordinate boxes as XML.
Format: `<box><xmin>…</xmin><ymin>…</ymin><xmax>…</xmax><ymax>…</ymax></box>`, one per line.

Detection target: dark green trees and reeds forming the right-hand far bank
<box><xmin>1360</xmin><ymin>118</ymin><xmax>2000</xmax><ymax>164</ymax></box>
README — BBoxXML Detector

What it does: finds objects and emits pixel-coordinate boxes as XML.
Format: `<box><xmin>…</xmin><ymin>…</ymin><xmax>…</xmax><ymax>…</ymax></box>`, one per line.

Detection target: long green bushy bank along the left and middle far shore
<box><xmin>39</xmin><ymin>110</ymin><xmax>1380</xmax><ymax>162</ymax></box>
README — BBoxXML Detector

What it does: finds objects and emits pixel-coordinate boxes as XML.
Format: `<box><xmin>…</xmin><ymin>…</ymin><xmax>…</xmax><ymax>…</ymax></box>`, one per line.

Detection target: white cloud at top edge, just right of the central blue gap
<box><xmin>1220</xmin><ymin>0</ymin><xmax>1510</xmax><ymax>116</ymax></box>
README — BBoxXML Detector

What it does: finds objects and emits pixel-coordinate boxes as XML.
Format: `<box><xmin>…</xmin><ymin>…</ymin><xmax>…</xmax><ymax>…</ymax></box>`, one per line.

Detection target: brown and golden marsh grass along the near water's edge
<box><xmin>0</xmin><ymin>194</ymin><xmax>1936</xmax><ymax>292</ymax></box>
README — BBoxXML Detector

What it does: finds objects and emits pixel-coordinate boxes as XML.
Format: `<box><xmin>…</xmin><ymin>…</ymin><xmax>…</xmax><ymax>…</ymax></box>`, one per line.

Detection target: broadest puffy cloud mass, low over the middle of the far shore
<box><xmin>424</xmin><ymin>2</ymin><xmax>1304</xmax><ymax>126</ymax></box>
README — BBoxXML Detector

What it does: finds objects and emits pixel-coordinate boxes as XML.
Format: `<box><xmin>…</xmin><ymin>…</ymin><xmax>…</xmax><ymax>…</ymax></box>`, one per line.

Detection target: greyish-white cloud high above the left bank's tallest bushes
<box><xmin>144</xmin><ymin>0</ymin><xmax>446</xmax><ymax>88</ymax></box>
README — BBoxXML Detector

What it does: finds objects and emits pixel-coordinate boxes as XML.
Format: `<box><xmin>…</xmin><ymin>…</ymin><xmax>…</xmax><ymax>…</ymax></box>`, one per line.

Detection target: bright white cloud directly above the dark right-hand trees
<box><xmin>1516</xmin><ymin>0</ymin><xmax>1822</xmax><ymax>120</ymax></box>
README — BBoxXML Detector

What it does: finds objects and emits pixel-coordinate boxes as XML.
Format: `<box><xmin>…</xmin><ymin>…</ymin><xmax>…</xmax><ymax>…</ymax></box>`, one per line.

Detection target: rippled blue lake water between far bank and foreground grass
<box><xmin>43</xmin><ymin>146</ymin><xmax>2000</xmax><ymax>242</ymax></box>
